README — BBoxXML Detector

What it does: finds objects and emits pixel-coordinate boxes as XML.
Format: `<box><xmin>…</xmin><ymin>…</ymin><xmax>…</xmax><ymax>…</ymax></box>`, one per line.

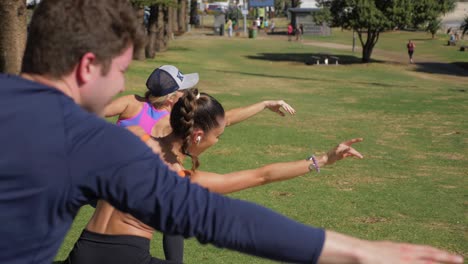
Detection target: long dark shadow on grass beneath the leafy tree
<box><xmin>246</xmin><ymin>52</ymin><xmax>383</xmax><ymax>66</ymax></box>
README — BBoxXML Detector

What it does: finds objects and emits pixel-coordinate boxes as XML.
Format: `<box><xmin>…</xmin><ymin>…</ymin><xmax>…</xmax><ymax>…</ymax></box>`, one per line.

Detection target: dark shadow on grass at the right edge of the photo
<box><xmin>416</xmin><ymin>62</ymin><xmax>468</xmax><ymax>77</ymax></box>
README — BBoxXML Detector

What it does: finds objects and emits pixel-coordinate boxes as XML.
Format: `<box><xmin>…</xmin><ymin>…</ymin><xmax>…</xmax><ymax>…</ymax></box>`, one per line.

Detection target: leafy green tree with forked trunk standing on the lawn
<box><xmin>313</xmin><ymin>0</ymin><xmax>455</xmax><ymax>63</ymax></box>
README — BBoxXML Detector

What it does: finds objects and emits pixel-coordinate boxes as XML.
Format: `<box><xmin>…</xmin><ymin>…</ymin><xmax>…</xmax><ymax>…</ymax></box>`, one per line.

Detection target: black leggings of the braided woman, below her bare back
<box><xmin>63</xmin><ymin>230</ymin><xmax>178</xmax><ymax>264</ymax></box>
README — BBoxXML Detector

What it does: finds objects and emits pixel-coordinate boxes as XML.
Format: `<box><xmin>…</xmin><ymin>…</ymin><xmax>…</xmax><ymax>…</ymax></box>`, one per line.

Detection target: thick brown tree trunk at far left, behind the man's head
<box><xmin>0</xmin><ymin>0</ymin><xmax>27</xmax><ymax>74</ymax></box>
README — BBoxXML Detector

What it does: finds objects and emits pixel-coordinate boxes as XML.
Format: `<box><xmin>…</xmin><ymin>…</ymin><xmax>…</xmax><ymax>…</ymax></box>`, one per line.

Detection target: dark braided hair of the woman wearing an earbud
<box><xmin>170</xmin><ymin>88</ymin><xmax>224</xmax><ymax>170</ymax></box>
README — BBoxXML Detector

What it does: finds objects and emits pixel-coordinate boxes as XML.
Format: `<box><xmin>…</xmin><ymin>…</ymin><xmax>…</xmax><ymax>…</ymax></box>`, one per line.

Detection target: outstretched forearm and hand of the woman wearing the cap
<box><xmin>226</xmin><ymin>100</ymin><xmax>296</xmax><ymax>126</ymax></box>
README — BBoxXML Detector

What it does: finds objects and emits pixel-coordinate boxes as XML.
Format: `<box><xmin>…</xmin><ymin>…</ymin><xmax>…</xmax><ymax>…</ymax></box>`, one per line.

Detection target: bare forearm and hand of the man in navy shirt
<box><xmin>318</xmin><ymin>230</ymin><xmax>463</xmax><ymax>264</ymax></box>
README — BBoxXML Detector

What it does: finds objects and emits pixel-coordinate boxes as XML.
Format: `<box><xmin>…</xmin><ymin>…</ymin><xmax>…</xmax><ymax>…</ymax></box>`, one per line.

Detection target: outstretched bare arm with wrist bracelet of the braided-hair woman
<box><xmin>191</xmin><ymin>138</ymin><xmax>363</xmax><ymax>194</ymax></box>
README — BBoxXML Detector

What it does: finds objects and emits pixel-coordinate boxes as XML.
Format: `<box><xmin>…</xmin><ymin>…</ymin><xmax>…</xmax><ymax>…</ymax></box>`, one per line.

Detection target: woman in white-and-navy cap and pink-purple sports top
<box><xmin>105</xmin><ymin>65</ymin><xmax>296</xmax><ymax>137</ymax></box>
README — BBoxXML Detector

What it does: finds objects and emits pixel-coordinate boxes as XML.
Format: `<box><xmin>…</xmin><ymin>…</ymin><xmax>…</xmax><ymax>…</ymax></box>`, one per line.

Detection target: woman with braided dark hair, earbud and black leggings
<box><xmin>66</xmin><ymin>89</ymin><xmax>362</xmax><ymax>264</ymax></box>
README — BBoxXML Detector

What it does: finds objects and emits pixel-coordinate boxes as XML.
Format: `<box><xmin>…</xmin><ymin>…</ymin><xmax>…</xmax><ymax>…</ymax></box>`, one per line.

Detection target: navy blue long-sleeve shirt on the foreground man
<box><xmin>0</xmin><ymin>75</ymin><xmax>325</xmax><ymax>264</ymax></box>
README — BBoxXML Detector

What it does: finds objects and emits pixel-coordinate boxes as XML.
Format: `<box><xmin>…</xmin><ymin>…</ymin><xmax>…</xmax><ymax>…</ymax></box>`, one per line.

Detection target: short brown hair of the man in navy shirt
<box><xmin>21</xmin><ymin>0</ymin><xmax>142</xmax><ymax>78</ymax></box>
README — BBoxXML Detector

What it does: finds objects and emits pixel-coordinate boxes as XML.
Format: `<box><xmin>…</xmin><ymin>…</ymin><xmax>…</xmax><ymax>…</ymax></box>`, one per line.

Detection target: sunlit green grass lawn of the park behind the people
<box><xmin>57</xmin><ymin>28</ymin><xmax>468</xmax><ymax>263</ymax></box>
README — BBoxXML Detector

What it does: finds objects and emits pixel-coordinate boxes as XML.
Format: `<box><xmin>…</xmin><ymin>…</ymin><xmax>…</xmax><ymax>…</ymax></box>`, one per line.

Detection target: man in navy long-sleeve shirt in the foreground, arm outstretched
<box><xmin>0</xmin><ymin>0</ymin><xmax>463</xmax><ymax>264</ymax></box>
